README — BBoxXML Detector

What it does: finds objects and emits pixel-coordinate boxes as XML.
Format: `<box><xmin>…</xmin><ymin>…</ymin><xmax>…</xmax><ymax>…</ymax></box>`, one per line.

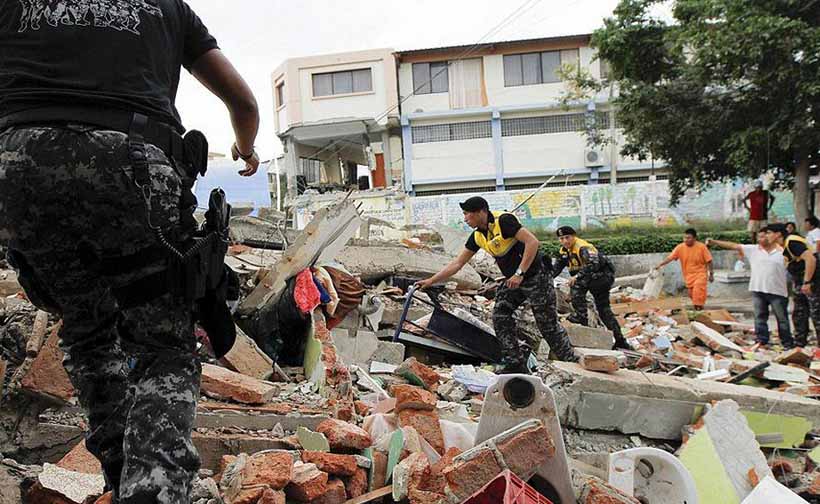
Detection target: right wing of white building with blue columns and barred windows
<box><xmin>396</xmin><ymin>35</ymin><xmax>651</xmax><ymax>195</ymax></box>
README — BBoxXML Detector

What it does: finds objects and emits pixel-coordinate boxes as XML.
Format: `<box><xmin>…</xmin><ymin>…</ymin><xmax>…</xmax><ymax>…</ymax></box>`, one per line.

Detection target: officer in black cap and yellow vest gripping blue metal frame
<box><xmin>416</xmin><ymin>196</ymin><xmax>578</xmax><ymax>373</ymax></box>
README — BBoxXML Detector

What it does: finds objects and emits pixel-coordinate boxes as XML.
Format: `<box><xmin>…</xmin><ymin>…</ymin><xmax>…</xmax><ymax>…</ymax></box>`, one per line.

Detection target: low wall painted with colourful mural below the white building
<box><xmin>296</xmin><ymin>181</ymin><xmax>794</xmax><ymax>233</ymax></box>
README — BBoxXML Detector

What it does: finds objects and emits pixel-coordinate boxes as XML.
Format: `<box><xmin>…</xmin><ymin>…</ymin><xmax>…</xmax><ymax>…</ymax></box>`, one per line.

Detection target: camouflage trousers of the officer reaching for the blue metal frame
<box><xmin>493</xmin><ymin>268</ymin><xmax>578</xmax><ymax>366</ymax></box>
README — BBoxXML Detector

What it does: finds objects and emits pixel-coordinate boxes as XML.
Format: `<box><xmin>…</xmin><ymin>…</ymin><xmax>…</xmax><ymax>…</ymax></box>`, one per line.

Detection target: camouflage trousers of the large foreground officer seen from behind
<box><xmin>0</xmin><ymin>126</ymin><xmax>201</xmax><ymax>504</ymax></box>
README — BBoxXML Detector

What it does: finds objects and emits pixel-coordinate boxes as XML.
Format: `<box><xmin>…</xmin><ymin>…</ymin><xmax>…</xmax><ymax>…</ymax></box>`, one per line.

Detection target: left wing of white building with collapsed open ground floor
<box><xmin>272</xmin><ymin>49</ymin><xmax>402</xmax><ymax>198</ymax></box>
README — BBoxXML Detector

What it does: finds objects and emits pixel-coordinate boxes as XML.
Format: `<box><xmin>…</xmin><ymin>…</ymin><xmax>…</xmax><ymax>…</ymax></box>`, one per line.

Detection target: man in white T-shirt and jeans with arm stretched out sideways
<box><xmin>706</xmin><ymin>227</ymin><xmax>794</xmax><ymax>348</ymax></box>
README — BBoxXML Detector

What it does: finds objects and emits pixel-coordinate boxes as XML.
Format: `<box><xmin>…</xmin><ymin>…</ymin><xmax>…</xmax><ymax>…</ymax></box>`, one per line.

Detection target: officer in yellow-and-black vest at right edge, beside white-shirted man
<box><xmin>766</xmin><ymin>224</ymin><xmax>820</xmax><ymax>346</ymax></box>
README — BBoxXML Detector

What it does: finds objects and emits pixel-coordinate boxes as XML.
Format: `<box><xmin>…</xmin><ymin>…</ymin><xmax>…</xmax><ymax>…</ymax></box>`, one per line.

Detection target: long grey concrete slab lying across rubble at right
<box><xmin>548</xmin><ymin>362</ymin><xmax>820</xmax><ymax>439</ymax></box>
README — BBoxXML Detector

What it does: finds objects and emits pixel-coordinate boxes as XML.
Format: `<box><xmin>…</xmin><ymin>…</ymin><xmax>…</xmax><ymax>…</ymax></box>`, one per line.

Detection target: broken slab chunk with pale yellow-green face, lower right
<box><xmin>679</xmin><ymin>400</ymin><xmax>772</xmax><ymax>504</ymax></box>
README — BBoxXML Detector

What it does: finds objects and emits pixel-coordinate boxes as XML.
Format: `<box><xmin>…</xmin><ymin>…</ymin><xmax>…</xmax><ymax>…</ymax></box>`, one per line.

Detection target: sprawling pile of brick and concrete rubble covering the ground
<box><xmin>0</xmin><ymin>202</ymin><xmax>820</xmax><ymax>504</ymax></box>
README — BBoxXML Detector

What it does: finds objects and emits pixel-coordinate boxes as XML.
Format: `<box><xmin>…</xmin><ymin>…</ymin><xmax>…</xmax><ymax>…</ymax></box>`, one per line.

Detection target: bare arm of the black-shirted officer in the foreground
<box><xmin>191</xmin><ymin>49</ymin><xmax>259</xmax><ymax>177</ymax></box>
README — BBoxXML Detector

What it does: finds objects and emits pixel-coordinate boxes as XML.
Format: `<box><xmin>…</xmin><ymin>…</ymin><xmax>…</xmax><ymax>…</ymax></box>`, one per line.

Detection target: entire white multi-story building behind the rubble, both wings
<box><xmin>273</xmin><ymin>35</ymin><xmax>660</xmax><ymax>205</ymax></box>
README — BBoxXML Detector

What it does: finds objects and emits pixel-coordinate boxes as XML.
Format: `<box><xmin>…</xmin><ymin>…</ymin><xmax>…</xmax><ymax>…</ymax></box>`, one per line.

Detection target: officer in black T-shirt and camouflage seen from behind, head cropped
<box><xmin>0</xmin><ymin>0</ymin><xmax>259</xmax><ymax>504</ymax></box>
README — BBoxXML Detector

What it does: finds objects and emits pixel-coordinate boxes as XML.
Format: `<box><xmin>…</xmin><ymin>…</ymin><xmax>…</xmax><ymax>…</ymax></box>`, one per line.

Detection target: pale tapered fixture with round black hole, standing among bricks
<box><xmin>476</xmin><ymin>373</ymin><xmax>576</xmax><ymax>502</ymax></box>
